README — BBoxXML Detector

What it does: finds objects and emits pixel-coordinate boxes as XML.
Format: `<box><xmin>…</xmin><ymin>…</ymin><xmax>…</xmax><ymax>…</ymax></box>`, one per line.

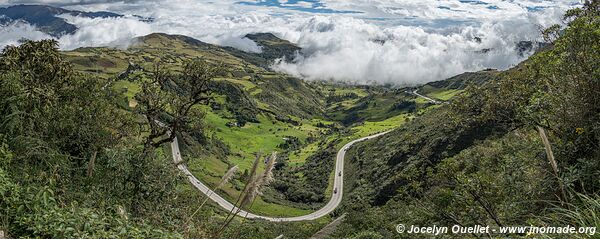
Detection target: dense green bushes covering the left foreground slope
<box><xmin>0</xmin><ymin>41</ymin><xmax>196</xmax><ymax>238</ymax></box>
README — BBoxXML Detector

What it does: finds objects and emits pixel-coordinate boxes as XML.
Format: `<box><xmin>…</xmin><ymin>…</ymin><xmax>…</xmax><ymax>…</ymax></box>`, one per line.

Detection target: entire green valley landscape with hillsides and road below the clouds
<box><xmin>0</xmin><ymin>1</ymin><xmax>600</xmax><ymax>239</ymax></box>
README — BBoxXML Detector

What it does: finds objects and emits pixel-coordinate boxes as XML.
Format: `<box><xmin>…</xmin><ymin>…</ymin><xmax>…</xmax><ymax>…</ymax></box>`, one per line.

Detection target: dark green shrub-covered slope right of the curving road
<box><xmin>333</xmin><ymin>1</ymin><xmax>600</xmax><ymax>238</ymax></box>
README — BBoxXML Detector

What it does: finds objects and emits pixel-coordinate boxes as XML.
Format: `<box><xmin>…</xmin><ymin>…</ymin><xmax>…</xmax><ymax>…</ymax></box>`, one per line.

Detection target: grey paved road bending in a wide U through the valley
<box><xmin>171</xmin><ymin>132</ymin><xmax>388</xmax><ymax>222</ymax></box>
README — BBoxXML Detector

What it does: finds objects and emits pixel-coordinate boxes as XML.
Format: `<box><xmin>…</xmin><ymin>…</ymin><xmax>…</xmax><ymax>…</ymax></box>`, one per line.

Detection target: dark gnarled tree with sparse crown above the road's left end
<box><xmin>135</xmin><ymin>60</ymin><xmax>218</xmax><ymax>150</ymax></box>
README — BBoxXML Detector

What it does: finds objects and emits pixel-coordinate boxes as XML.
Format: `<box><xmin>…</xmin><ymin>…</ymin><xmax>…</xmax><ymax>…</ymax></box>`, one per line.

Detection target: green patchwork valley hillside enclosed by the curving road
<box><xmin>64</xmin><ymin>33</ymin><xmax>472</xmax><ymax>216</ymax></box>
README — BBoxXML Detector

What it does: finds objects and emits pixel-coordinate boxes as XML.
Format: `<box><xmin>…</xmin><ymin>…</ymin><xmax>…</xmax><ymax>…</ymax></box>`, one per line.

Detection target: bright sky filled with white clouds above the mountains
<box><xmin>0</xmin><ymin>0</ymin><xmax>579</xmax><ymax>86</ymax></box>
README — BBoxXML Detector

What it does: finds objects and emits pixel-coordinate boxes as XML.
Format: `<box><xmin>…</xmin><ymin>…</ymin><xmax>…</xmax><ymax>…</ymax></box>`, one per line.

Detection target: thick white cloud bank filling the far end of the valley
<box><xmin>274</xmin><ymin>18</ymin><xmax>533</xmax><ymax>85</ymax></box>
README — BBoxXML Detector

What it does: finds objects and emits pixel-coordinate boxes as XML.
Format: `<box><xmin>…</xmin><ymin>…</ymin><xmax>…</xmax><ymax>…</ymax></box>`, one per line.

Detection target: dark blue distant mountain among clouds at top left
<box><xmin>0</xmin><ymin>5</ymin><xmax>152</xmax><ymax>37</ymax></box>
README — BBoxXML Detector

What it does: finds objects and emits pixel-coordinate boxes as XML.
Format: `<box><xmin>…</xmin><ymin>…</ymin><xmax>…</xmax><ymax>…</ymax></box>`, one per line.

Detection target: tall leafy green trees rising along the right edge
<box><xmin>524</xmin><ymin>1</ymin><xmax>600</xmax><ymax>192</ymax></box>
